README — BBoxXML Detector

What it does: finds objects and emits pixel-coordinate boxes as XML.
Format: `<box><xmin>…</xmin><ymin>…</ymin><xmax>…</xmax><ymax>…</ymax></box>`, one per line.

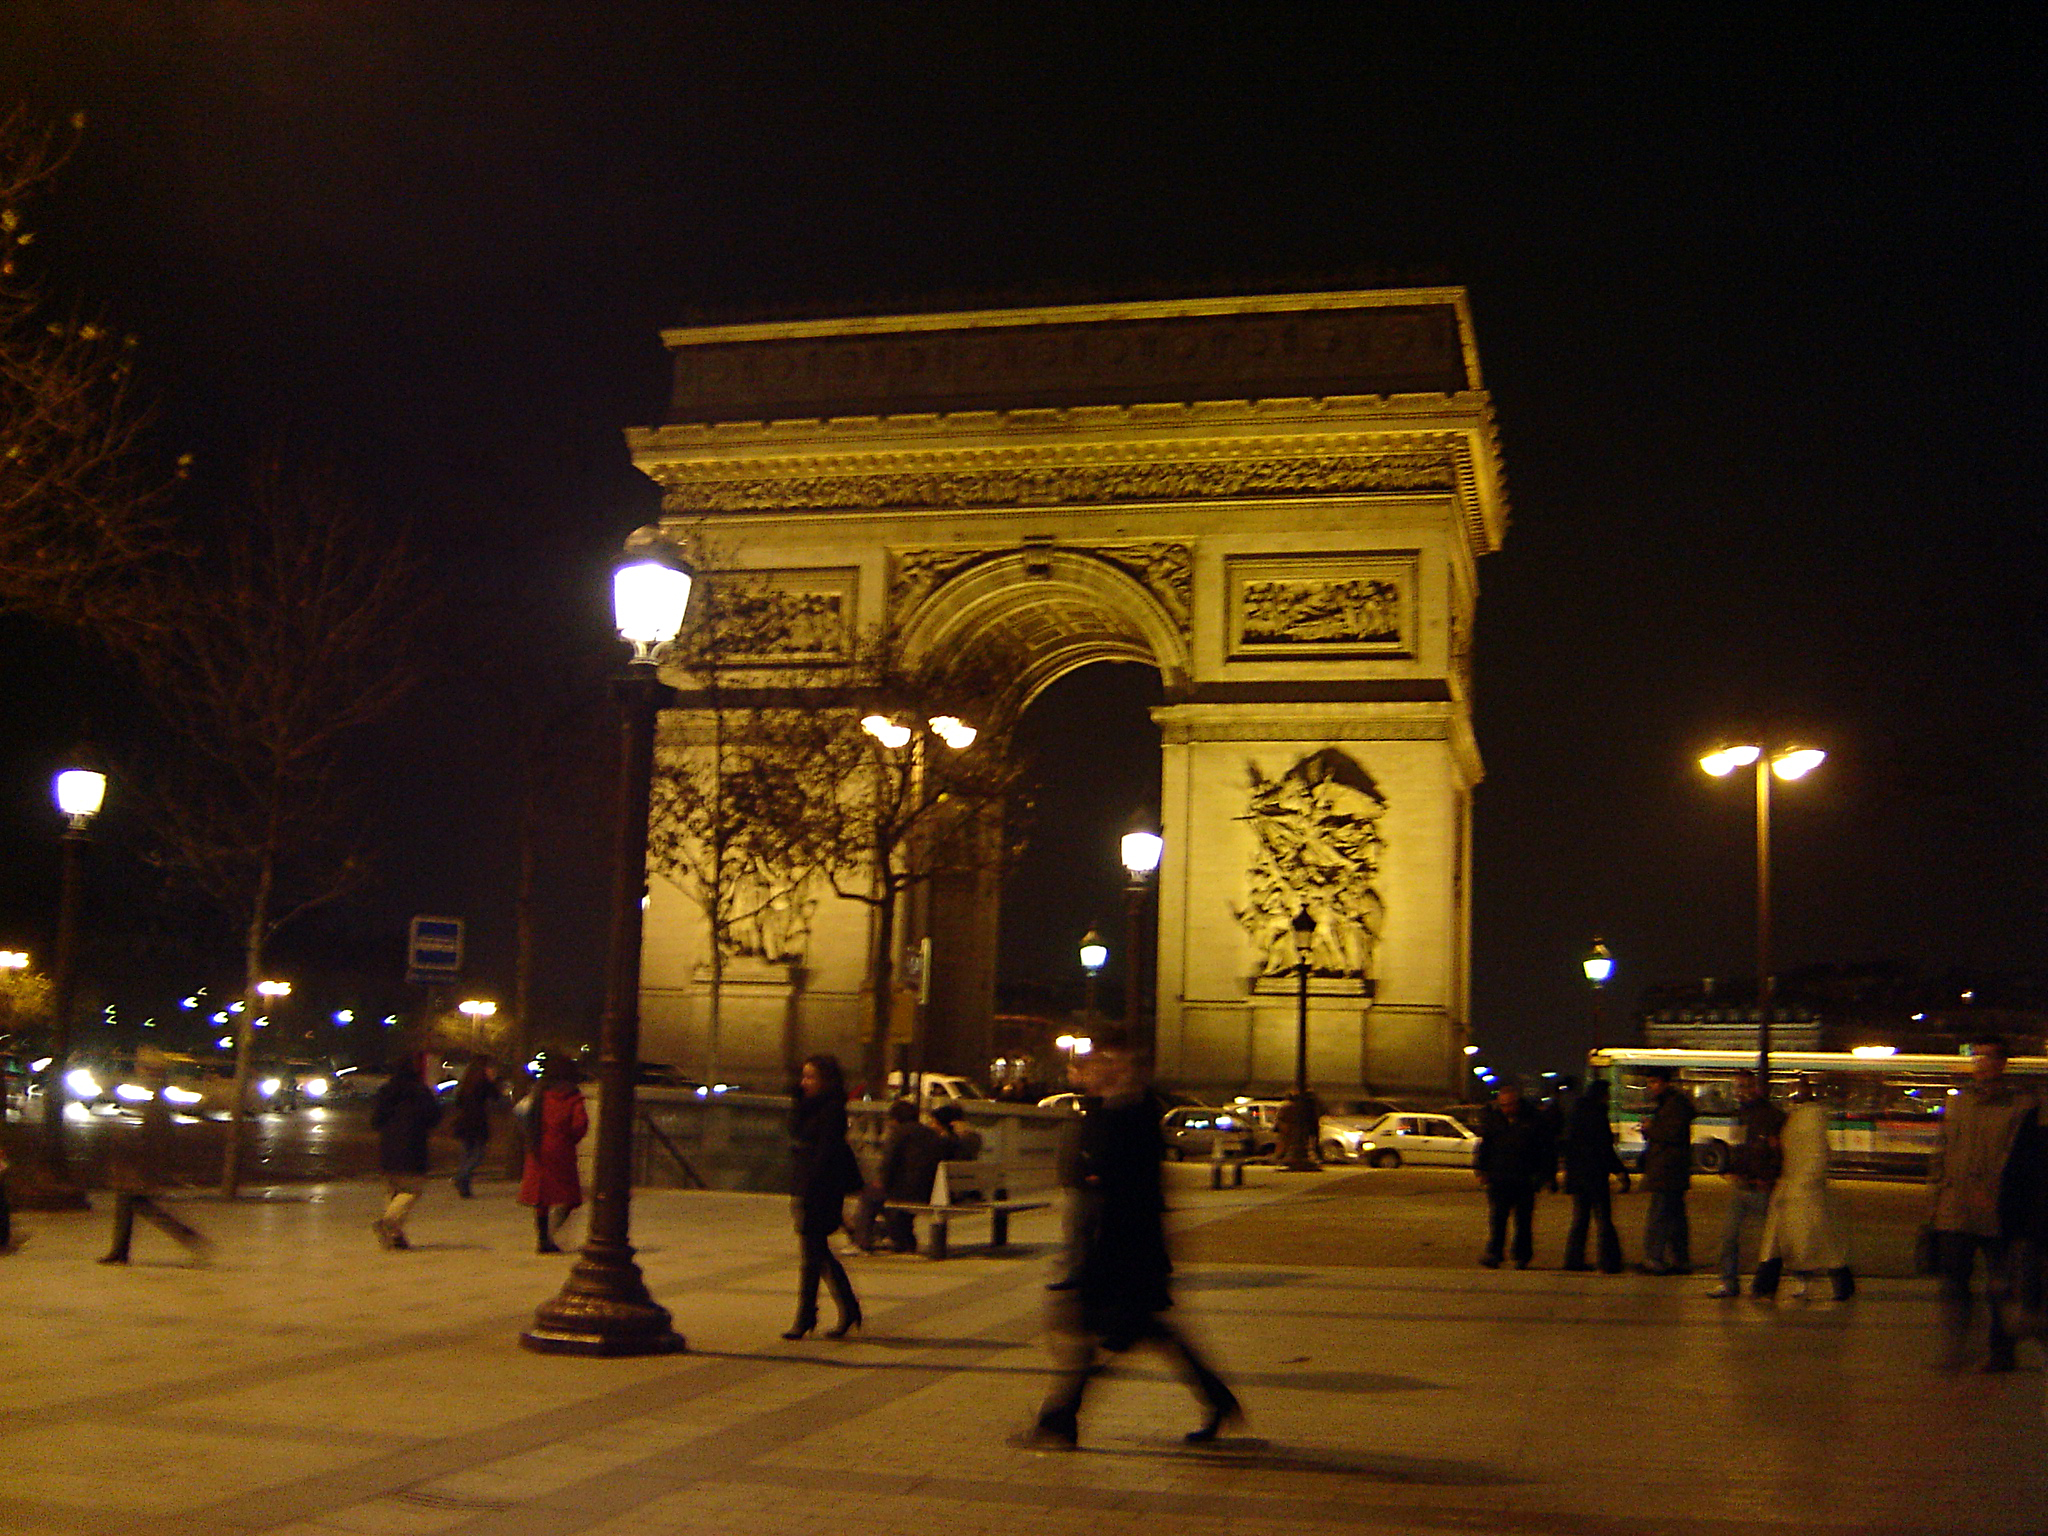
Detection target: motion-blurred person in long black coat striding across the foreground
<box><xmin>1022</xmin><ymin>1026</ymin><xmax>1243</xmax><ymax>1450</ymax></box>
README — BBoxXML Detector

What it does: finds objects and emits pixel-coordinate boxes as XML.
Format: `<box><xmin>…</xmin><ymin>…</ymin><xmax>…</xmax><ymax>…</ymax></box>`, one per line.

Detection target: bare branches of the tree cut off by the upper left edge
<box><xmin>0</xmin><ymin>106</ymin><xmax>172</xmax><ymax>633</ymax></box>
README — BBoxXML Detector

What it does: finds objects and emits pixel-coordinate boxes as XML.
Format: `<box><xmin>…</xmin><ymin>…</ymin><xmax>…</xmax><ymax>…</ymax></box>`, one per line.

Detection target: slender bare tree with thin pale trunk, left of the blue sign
<box><xmin>135</xmin><ymin>457</ymin><xmax>420</xmax><ymax>1198</ymax></box>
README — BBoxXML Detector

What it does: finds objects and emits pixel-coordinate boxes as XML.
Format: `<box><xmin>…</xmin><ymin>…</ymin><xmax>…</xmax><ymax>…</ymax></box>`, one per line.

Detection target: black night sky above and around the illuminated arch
<box><xmin>0</xmin><ymin>0</ymin><xmax>2048</xmax><ymax>1067</ymax></box>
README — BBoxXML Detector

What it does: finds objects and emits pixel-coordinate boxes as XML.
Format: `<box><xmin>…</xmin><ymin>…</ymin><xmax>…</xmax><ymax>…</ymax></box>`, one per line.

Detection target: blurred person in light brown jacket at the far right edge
<box><xmin>1927</xmin><ymin>1034</ymin><xmax>2040</xmax><ymax>1370</ymax></box>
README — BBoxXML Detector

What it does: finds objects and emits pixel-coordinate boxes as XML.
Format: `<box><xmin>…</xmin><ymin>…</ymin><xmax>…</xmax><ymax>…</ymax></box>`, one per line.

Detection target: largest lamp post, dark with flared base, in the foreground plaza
<box><xmin>520</xmin><ymin>549</ymin><xmax>690</xmax><ymax>1356</ymax></box>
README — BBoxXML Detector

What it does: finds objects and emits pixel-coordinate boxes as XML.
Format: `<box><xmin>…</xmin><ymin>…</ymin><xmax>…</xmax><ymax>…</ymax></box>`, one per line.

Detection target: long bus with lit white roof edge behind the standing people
<box><xmin>1585</xmin><ymin>1047</ymin><xmax>2048</xmax><ymax>1178</ymax></box>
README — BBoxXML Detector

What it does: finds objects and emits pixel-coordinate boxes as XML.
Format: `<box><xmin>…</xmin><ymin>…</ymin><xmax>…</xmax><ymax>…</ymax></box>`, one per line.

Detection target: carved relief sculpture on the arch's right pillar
<box><xmin>1235</xmin><ymin>748</ymin><xmax>1386</xmax><ymax>979</ymax></box>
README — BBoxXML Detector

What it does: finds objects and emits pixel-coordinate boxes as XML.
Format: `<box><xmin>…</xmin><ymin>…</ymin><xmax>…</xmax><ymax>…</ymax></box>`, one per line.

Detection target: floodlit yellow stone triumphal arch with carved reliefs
<box><xmin>629</xmin><ymin>289</ymin><xmax>1507</xmax><ymax>1094</ymax></box>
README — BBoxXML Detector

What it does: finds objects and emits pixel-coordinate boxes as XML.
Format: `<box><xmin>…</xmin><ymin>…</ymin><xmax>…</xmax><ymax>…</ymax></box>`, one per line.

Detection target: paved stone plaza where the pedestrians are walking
<box><xmin>0</xmin><ymin>1169</ymin><xmax>2048</xmax><ymax>1536</ymax></box>
